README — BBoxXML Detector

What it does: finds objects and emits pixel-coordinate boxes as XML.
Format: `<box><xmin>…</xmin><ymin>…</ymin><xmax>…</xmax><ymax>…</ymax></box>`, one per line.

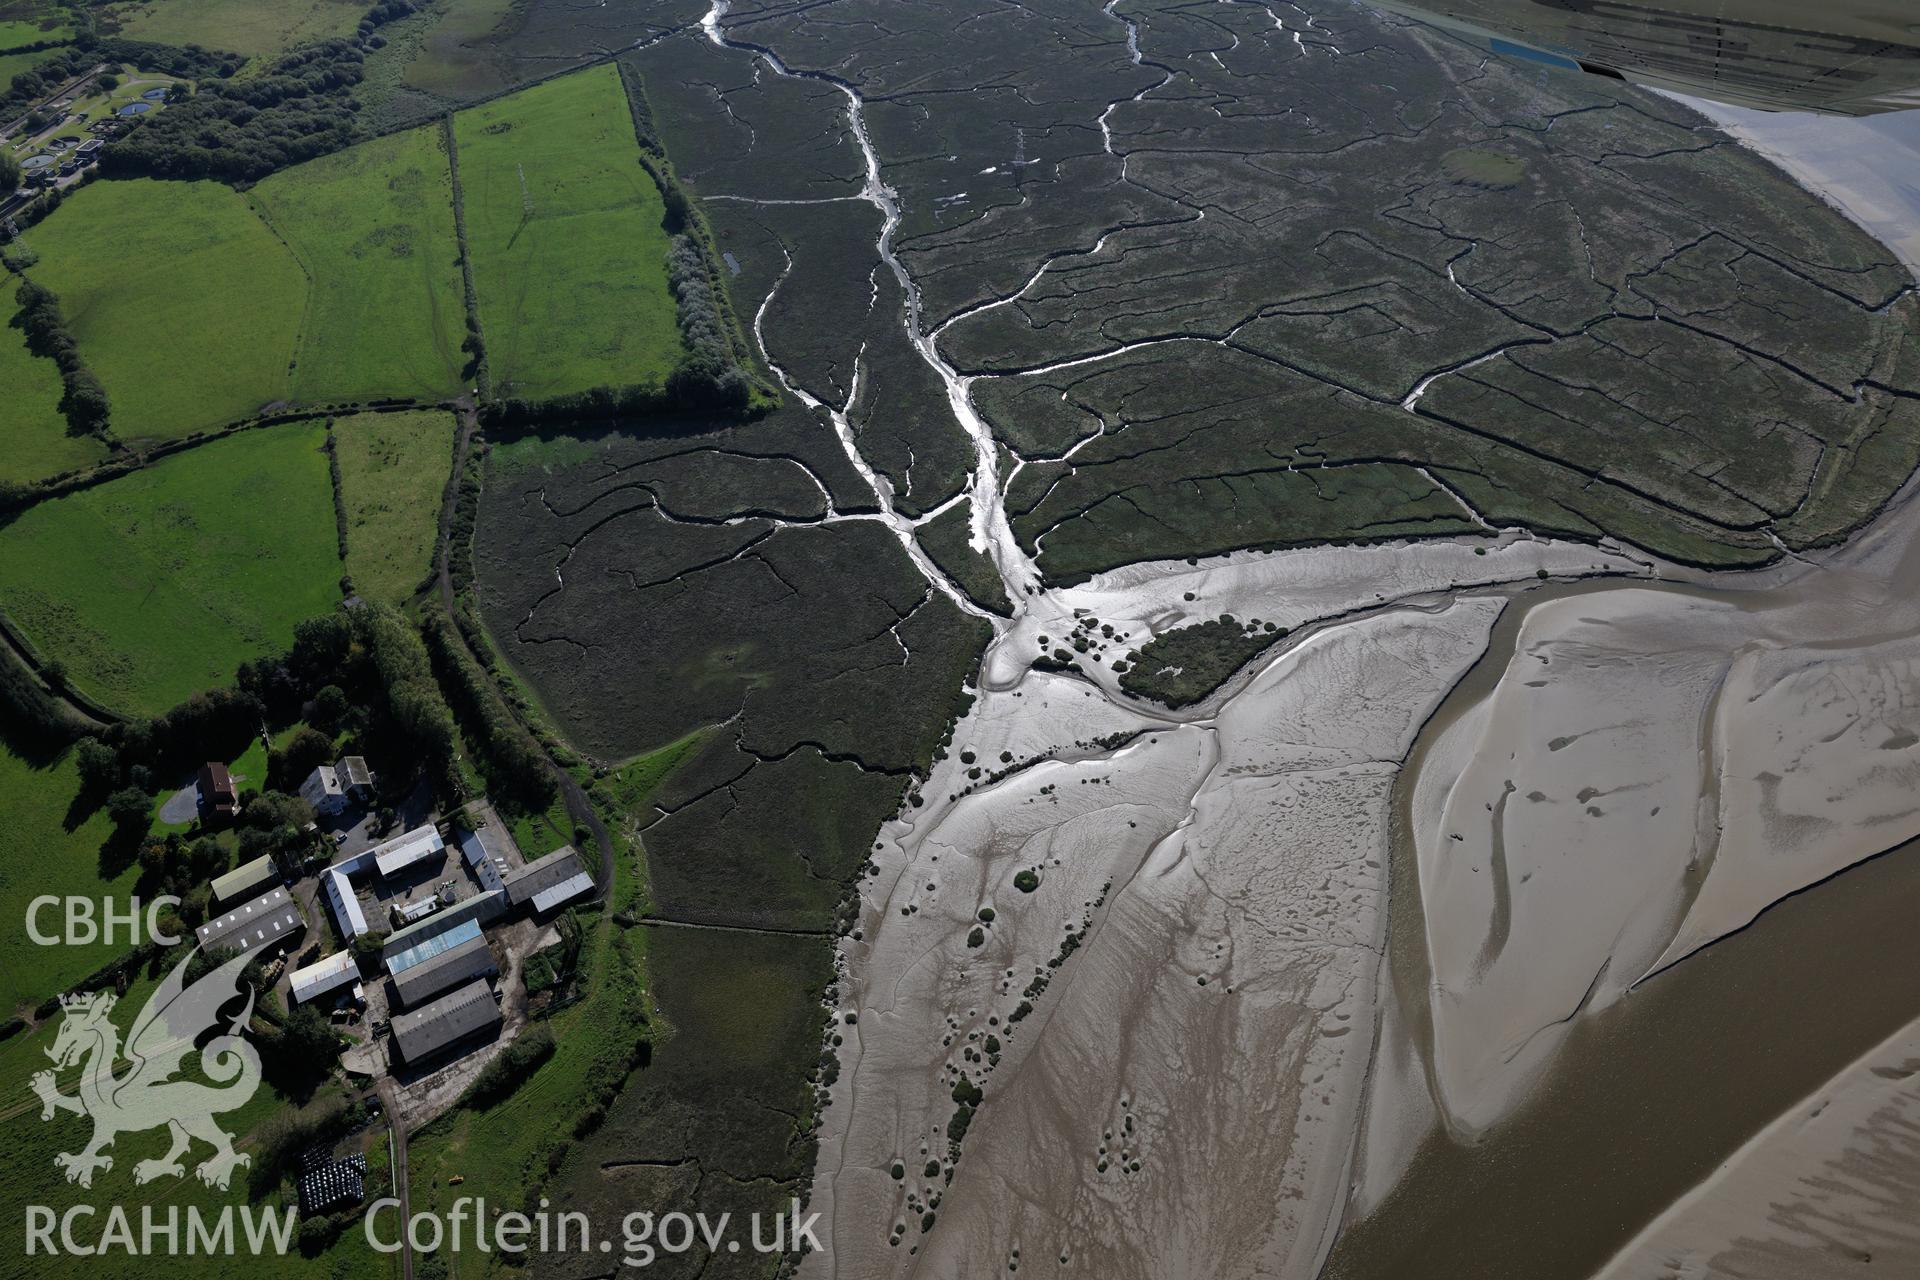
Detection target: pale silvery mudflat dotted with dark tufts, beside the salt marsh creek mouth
<box><xmin>810</xmin><ymin>537</ymin><xmax>1645</xmax><ymax>1278</ymax></box>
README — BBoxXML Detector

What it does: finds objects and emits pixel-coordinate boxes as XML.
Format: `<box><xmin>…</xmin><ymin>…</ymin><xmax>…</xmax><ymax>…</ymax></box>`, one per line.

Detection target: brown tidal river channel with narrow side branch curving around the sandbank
<box><xmin>1321</xmin><ymin>583</ymin><xmax>1920</xmax><ymax>1280</ymax></box>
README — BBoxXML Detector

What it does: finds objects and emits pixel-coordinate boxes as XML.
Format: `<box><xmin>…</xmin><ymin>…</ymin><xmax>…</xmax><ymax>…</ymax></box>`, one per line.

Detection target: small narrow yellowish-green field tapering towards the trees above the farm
<box><xmin>334</xmin><ymin>411</ymin><xmax>453</xmax><ymax>604</ymax></box>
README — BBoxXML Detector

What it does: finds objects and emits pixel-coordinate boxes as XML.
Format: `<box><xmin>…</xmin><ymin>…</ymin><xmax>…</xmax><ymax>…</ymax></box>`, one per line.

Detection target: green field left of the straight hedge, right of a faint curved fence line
<box><xmin>252</xmin><ymin>127</ymin><xmax>467</xmax><ymax>403</ymax></box>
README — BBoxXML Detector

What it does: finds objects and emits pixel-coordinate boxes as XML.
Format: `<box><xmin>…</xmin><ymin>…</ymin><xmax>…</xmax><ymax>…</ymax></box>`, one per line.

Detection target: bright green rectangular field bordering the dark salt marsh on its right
<box><xmin>453</xmin><ymin>65</ymin><xmax>682</xmax><ymax>397</ymax></box>
